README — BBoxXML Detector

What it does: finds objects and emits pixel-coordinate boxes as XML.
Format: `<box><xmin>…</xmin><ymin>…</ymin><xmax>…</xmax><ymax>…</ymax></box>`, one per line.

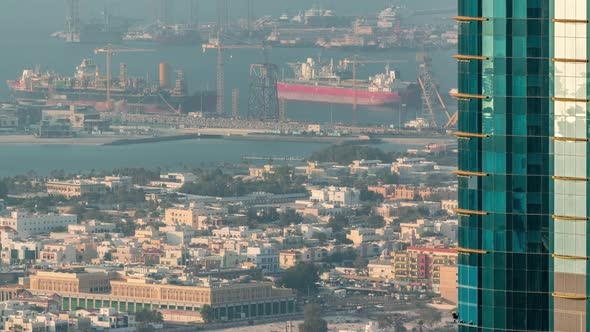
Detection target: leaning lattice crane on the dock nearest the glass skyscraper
<box><xmin>418</xmin><ymin>55</ymin><xmax>459</xmax><ymax>129</ymax></box>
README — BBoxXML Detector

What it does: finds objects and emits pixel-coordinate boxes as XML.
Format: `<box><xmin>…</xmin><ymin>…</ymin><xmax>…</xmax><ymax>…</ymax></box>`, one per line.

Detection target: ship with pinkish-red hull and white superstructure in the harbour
<box><xmin>278</xmin><ymin>58</ymin><xmax>413</xmax><ymax>106</ymax></box>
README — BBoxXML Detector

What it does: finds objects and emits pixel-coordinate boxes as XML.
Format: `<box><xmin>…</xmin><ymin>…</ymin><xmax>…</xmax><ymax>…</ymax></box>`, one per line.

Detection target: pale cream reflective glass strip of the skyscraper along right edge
<box><xmin>549</xmin><ymin>0</ymin><xmax>590</xmax><ymax>331</ymax></box>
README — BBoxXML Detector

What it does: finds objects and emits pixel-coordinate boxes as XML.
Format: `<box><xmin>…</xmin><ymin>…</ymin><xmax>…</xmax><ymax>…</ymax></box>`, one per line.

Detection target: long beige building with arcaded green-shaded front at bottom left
<box><xmin>28</xmin><ymin>271</ymin><xmax>298</xmax><ymax>320</ymax></box>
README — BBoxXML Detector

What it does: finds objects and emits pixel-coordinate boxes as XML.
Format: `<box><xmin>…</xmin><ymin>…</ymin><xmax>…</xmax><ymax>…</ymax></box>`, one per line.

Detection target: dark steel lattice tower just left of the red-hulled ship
<box><xmin>248</xmin><ymin>63</ymin><xmax>279</xmax><ymax>121</ymax></box>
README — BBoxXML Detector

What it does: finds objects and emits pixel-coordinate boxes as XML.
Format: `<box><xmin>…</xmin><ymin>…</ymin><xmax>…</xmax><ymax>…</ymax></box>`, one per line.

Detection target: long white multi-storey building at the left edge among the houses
<box><xmin>0</xmin><ymin>211</ymin><xmax>78</xmax><ymax>238</ymax></box>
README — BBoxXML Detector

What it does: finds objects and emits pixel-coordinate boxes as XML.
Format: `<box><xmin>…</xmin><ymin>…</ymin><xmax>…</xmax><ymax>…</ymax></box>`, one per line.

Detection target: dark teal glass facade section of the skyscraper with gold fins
<box><xmin>456</xmin><ymin>0</ymin><xmax>553</xmax><ymax>332</ymax></box>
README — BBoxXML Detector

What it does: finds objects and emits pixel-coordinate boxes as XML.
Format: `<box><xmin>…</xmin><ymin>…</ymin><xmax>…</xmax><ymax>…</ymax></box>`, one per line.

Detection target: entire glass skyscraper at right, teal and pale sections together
<box><xmin>455</xmin><ymin>0</ymin><xmax>556</xmax><ymax>331</ymax></box>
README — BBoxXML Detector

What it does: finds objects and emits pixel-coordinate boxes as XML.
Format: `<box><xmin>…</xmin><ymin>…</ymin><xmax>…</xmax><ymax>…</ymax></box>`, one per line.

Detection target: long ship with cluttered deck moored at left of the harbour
<box><xmin>7</xmin><ymin>59</ymin><xmax>217</xmax><ymax>113</ymax></box>
